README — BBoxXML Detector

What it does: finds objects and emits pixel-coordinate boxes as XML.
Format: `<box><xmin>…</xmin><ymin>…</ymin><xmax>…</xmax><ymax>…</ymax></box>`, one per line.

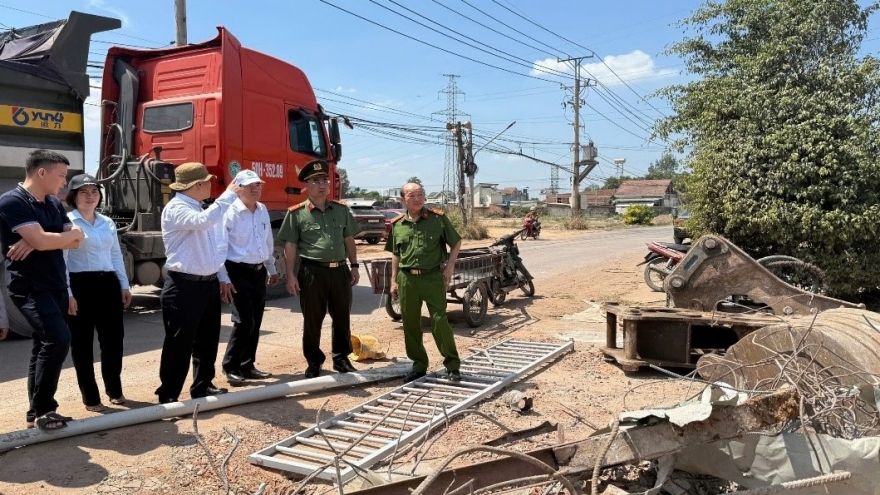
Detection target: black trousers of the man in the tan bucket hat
<box><xmin>156</xmin><ymin>272</ymin><xmax>220</xmax><ymax>402</ymax></box>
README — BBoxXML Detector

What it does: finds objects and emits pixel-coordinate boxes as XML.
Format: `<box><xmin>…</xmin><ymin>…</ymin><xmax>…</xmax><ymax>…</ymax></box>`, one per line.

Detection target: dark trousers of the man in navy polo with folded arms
<box><xmin>9</xmin><ymin>290</ymin><xmax>70</xmax><ymax>422</ymax></box>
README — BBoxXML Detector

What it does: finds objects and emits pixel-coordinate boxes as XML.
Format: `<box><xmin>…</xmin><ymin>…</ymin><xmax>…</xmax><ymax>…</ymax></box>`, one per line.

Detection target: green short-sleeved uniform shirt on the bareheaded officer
<box><xmin>385</xmin><ymin>209</ymin><xmax>461</xmax><ymax>270</ymax></box>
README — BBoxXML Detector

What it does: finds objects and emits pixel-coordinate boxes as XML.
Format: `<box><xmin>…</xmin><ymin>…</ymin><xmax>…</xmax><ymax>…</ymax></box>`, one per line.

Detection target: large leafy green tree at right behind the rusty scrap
<box><xmin>657</xmin><ymin>0</ymin><xmax>880</xmax><ymax>296</ymax></box>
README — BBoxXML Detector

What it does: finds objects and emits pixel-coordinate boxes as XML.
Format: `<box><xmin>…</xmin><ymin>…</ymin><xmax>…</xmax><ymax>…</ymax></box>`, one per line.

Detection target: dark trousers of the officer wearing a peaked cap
<box><xmin>297</xmin><ymin>260</ymin><xmax>351</xmax><ymax>365</ymax></box>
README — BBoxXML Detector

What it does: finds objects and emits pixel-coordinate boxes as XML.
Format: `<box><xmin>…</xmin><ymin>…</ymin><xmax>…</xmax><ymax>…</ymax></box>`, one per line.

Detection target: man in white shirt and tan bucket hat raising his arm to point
<box><xmin>156</xmin><ymin>163</ymin><xmax>241</xmax><ymax>404</ymax></box>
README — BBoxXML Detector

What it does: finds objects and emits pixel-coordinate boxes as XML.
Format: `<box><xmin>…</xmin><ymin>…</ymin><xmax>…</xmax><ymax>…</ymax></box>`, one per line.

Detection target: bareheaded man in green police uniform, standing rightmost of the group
<box><xmin>385</xmin><ymin>182</ymin><xmax>461</xmax><ymax>383</ymax></box>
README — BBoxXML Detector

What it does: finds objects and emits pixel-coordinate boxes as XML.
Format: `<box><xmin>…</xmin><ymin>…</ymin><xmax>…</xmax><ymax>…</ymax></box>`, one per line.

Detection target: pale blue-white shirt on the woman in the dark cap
<box><xmin>64</xmin><ymin>209</ymin><xmax>130</xmax><ymax>295</ymax></box>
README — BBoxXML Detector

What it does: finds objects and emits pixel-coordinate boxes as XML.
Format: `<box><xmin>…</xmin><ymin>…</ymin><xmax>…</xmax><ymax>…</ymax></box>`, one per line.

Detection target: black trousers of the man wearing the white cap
<box><xmin>223</xmin><ymin>261</ymin><xmax>267</xmax><ymax>371</ymax></box>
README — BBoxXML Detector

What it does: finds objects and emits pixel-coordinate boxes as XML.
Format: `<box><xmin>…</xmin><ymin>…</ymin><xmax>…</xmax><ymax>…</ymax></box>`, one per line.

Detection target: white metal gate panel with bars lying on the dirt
<box><xmin>248</xmin><ymin>340</ymin><xmax>574</xmax><ymax>483</ymax></box>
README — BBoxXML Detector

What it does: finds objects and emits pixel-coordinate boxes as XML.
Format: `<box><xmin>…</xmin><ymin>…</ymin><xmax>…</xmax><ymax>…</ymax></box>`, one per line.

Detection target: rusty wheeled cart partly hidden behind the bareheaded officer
<box><xmin>365</xmin><ymin>248</ymin><xmax>504</xmax><ymax>327</ymax></box>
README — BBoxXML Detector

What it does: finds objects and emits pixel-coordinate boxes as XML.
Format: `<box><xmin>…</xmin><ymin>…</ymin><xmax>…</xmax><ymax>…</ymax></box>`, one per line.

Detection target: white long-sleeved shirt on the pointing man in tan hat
<box><xmin>162</xmin><ymin>191</ymin><xmax>238</xmax><ymax>282</ymax></box>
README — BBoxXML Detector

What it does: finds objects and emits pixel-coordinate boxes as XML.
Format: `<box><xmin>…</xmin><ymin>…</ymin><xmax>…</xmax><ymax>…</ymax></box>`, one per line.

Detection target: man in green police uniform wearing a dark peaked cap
<box><xmin>278</xmin><ymin>160</ymin><xmax>360</xmax><ymax>378</ymax></box>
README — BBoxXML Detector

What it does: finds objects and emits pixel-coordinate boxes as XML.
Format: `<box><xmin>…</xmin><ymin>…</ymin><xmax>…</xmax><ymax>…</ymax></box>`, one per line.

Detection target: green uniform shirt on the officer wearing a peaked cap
<box><xmin>278</xmin><ymin>200</ymin><xmax>360</xmax><ymax>263</ymax></box>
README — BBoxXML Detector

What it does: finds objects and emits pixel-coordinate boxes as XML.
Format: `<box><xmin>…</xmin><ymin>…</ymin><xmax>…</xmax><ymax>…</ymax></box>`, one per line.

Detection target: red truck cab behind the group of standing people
<box><xmin>101</xmin><ymin>27</ymin><xmax>341</xmax><ymax>216</ymax></box>
